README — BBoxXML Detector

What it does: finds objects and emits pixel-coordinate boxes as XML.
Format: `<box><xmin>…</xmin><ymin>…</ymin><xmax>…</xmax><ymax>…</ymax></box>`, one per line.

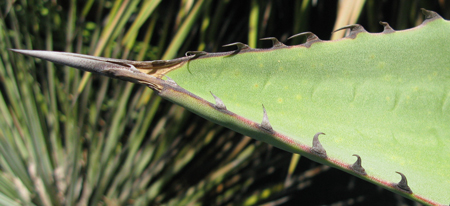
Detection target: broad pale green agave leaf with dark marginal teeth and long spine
<box><xmin>13</xmin><ymin>10</ymin><xmax>450</xmax><ymax>204</ymax></box>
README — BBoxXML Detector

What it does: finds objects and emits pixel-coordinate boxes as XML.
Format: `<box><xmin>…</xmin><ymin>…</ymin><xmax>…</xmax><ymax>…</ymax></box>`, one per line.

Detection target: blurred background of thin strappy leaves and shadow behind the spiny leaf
<box><xmin>0</xmin><ymin>0</ymin><xmax>450</xmax><ymax>205</ymax></box>
